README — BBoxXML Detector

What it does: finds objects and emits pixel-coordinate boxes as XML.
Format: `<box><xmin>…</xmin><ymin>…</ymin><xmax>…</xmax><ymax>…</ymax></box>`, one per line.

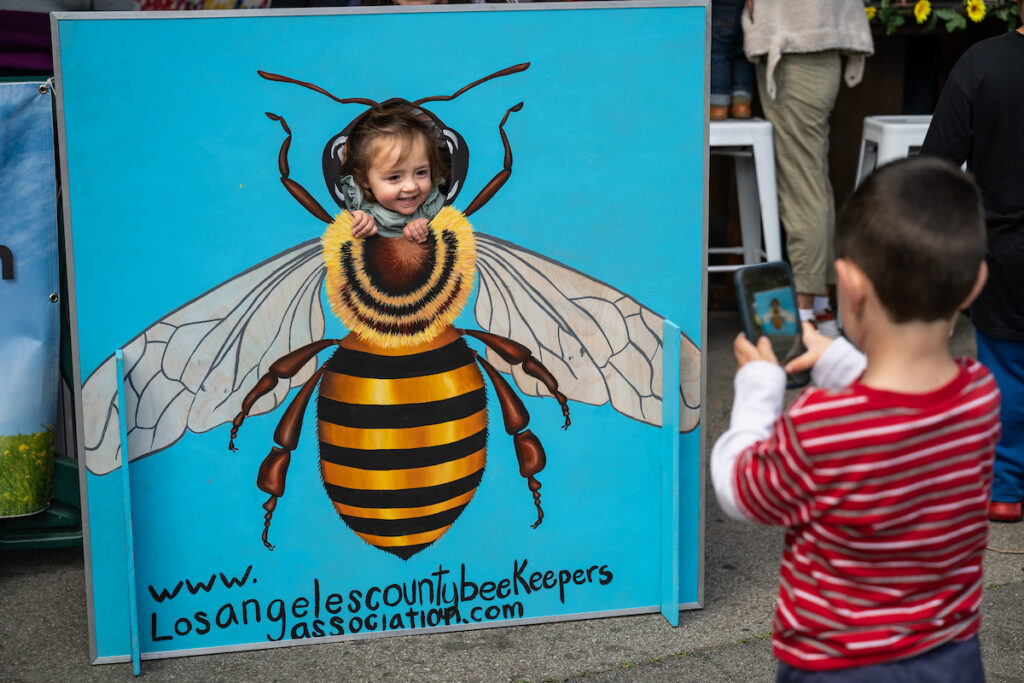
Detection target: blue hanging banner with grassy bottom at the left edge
<box><xmin>0</xmin><ymin>83</ymin><xmax>60</xmax><ymax>517</ymax></box>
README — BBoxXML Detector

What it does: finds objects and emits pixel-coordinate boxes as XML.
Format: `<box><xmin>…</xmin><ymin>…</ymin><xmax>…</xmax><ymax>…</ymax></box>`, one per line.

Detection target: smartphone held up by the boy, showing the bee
<box><xmin>734</xmin><ymin>261</ymin><xmax>811</xmax><ymax>389</ymax></box>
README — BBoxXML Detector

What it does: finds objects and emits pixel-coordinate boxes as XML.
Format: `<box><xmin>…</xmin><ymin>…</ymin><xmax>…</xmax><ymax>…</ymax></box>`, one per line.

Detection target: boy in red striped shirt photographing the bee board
<box><xmin>711</xmin><ymin>158</ymin><xmax>999</xmax><ymax>683</ymax></box>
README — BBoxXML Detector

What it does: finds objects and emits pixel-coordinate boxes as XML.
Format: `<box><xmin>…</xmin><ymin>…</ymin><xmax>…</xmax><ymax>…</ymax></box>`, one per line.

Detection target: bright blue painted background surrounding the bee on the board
<box><xmin>59</xmin><ymin>6</ymin><xmax>706</xmax><ymax>657</ymax></box>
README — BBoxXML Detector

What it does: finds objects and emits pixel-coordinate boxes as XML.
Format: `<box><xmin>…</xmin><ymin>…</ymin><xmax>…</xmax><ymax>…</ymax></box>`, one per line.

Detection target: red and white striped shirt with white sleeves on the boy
<box><xmin>712</xmin><ymin>341</ymin><xmax>999</xmax><ymax>670</ymax></box>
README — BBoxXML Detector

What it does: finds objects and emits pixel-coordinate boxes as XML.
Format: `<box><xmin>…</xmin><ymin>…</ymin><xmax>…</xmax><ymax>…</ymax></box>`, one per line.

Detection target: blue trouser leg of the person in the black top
<box><xmin>975</xmin><ymin>330</ymin><xmax>1024</xmax><ymax>518</ymax></box>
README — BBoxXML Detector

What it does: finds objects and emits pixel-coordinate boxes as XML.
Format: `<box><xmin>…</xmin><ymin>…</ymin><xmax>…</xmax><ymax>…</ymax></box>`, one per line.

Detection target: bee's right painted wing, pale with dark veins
<box><xmin>474</xmin><ymin>232</ymin><xmax>700</xmax><ymax>431</ymax></box>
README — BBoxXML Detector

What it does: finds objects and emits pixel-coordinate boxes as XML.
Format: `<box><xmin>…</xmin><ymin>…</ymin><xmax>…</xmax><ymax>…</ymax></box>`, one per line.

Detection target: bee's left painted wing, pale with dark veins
<box><xmin>82</xmin><ymin>240</ymin><xmax>325</xmax><ymax>474</ymax></box>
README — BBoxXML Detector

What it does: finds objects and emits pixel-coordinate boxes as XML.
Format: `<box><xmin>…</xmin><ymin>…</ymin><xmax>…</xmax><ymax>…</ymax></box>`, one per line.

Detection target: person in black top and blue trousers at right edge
<box><xmin>921</xmin><ymin>12</ymin><xmax>1024</xmax><ymax>521</ymax></box>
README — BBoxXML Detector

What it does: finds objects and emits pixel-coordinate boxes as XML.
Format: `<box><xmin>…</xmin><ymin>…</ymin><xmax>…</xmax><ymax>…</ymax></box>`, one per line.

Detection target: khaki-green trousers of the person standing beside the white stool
<box><xmin>757</xmin><ymin>50</ymin><xmax>841</xmax><ymax>309</ymax></box>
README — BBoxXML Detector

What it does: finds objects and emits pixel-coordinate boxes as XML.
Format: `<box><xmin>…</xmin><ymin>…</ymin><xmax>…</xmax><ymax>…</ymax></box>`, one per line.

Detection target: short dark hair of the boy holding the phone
<box><xmin>836</xmin><ymin>157</ymin><xmax>985</xmax><ymax>323</ymax></box>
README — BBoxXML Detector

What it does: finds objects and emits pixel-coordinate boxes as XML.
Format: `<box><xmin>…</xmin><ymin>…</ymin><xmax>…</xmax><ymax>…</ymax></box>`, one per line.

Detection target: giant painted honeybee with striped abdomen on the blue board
<box><xmin>77</xmin><ymin>63</ymin><xmax>700</xmax><ymax>558</ymax></box>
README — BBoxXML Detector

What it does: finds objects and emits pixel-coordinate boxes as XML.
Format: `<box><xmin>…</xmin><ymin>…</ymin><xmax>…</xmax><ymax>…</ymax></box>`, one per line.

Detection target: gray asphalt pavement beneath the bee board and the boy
<box><xmin>0</xmin><ymin>311</ymin><xmax>1024</xmax><ymax>683</ymax></box>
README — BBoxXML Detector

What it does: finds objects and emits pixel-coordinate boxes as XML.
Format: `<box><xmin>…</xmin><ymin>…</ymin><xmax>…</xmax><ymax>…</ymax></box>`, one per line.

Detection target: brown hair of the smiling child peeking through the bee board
<box><xmin>341</xmin><ymin>104</ymin><xmax>449</xmax><ymax>202</ymax></box>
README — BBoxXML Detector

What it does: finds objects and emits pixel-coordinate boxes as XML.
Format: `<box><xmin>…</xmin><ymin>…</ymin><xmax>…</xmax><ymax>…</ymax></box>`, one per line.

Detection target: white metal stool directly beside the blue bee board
<box><xmin>708</xmin><ymin>119</ymin><xmax>782</xmax><ymax>272</ymax></box>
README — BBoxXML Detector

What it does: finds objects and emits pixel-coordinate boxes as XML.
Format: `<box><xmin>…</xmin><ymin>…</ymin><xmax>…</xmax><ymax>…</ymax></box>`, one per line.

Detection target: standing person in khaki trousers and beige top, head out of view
<box><xmin>742</xmin><ymin>0</ymin><xmax>874</xmax><ymax>327</ymax></box>
